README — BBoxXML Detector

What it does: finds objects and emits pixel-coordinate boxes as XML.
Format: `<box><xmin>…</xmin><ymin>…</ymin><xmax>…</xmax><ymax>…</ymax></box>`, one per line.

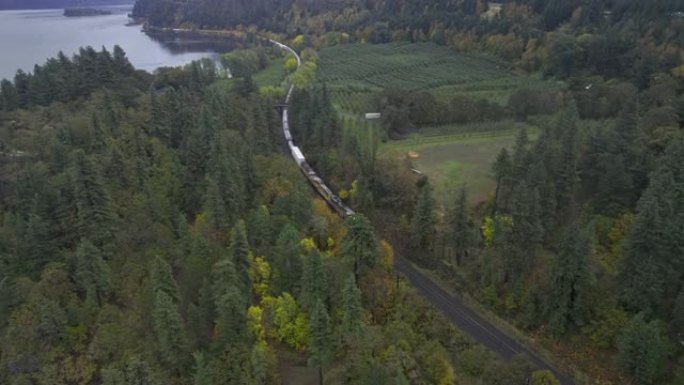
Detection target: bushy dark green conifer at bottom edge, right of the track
<box><xmin>618</xmin><ymin>314</ymin><xmax>666</xmax><ymax>385</ymax></box>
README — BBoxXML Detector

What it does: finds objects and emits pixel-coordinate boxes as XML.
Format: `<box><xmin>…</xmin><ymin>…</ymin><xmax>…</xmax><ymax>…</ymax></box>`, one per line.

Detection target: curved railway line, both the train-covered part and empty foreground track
<box><xmin>269</xmin><ymin>39</ymin><xmax>574</xmax><ymax>385</ymax></box>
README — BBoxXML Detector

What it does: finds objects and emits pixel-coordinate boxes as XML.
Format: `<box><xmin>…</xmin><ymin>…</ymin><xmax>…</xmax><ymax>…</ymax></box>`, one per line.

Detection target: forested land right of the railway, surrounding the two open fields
<box><xmin>127</xmin><ymin>0</ymin><xmax>684</xmax><ymax>385</ymax></box>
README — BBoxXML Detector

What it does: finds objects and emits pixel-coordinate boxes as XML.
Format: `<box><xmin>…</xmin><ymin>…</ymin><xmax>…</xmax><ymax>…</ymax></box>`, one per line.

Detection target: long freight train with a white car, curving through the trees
<box><xmin>270</xmin><ymin>40</ymin><xmax>356</xmax><ymax>218</ymax></box>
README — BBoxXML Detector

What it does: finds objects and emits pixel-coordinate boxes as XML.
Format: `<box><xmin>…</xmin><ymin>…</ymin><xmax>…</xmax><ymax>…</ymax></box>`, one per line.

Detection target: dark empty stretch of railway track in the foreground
<box><xmin>395</xmin><ymin>257</ymin><xmax>574</xmax><ymax>385</ymax></box>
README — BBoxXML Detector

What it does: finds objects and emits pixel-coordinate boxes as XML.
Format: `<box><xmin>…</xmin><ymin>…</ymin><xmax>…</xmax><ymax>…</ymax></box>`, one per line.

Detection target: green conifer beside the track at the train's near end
<box><xmin>341</xmin><ymin>214</ymin><xmax>379</xmax><ymax>282</ymax></box>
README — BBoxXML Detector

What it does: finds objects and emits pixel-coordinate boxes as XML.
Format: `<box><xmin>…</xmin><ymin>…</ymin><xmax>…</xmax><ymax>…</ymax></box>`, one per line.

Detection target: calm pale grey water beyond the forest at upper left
<box><xmin>0</xmin><ymin>7</ymin><xmax>218</xmax><ymax>79</ymax></box>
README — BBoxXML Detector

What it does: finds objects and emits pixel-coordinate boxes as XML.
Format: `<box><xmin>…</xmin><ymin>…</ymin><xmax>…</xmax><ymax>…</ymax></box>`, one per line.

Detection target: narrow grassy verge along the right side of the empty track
<box><xmin>409</xmin><ymin>262</ymin><xmax>591</xmax><ymax>385</ymax></box>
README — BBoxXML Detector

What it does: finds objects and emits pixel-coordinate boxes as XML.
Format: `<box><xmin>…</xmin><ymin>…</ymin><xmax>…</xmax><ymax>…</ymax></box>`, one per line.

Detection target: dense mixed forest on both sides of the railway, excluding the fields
<box><xmin>0</xmin><ymin>0</ymin><xmax>684</xmax><ymax>385</ymax></box>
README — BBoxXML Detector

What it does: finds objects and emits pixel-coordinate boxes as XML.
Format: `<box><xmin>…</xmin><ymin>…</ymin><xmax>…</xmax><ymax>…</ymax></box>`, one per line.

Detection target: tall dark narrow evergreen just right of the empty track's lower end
<box><xmin>548</xmin><ymin>224</ymin><xmax>590</xmax><ymax>335</ymax></box>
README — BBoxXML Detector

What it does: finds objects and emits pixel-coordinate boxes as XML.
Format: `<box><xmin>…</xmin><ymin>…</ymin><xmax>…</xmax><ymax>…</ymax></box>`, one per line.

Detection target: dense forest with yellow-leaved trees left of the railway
<box><xmin>0</xmin><ymin>43</ymin><xmax>568</xmax><ymax>385</ymax></box>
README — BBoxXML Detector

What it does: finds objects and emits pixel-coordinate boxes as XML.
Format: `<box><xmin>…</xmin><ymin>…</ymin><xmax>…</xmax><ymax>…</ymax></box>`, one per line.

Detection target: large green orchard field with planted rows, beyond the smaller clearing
<box><xmin>318</xmin><ymin>43</ymin><xmax>563</xmax><ymax>113</ymax></box>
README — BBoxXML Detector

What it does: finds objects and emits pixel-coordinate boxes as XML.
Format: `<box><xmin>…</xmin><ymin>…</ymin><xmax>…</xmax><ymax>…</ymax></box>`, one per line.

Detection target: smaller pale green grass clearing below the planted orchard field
<box><xmin>380</xmin><ymin>126</ymin><xmax>536</xmax><ymax>206</ymax></box>
